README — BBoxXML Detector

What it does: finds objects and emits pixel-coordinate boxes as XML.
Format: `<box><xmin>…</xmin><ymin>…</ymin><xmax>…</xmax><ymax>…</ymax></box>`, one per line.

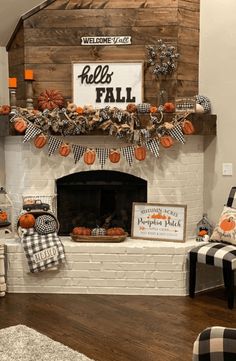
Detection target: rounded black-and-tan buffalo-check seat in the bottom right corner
<box><xmin>193</xmin><ymin>326</ymin><xmax>236</xmax><ymax>361</ymax></box>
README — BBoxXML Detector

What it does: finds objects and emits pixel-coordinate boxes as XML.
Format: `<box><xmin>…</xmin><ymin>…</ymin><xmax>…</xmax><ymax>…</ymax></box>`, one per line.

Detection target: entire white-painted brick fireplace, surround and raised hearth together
<box><xmin>4</xmin><ymin>136</ymin><xmax>223</xmax><ymax>295</ymax></box>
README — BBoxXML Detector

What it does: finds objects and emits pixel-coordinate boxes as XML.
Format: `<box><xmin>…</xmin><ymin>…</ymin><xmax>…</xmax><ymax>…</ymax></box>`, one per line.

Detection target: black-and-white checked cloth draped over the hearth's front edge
<box><xmin>21</xmin><ymin>228</ymin><xmax>65</xmax><ymax>273</ymax></box>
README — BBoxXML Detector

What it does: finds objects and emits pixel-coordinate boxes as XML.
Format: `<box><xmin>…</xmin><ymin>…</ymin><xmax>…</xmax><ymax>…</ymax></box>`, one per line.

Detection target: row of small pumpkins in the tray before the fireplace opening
<box><xmin>72</xmin><ymin>227</ymin><xmax>126</xmax><ymax>237</ymax></box>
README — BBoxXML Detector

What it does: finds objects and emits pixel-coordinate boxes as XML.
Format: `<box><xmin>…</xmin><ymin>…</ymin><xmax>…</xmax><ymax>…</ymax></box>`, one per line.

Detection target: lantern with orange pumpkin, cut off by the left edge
<box><xmin>0</xmin><ymin>187</ymin><xmax>13</xmax><ymax>238</ymax></box>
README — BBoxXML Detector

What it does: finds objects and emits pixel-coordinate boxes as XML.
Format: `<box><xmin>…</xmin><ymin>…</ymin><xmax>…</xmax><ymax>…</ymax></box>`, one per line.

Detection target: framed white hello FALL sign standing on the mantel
<box><xmin>73</xmin><ymin>62</ymin><xmax>143</xmax><ymax>109</ymax></box>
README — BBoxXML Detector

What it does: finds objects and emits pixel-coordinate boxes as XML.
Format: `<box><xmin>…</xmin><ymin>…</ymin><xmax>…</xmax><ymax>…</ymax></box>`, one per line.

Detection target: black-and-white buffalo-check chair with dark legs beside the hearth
<box><xmin>189</xmin><ymin>187</ymin><xmax>236</xmax><ymax>308</ymax></box>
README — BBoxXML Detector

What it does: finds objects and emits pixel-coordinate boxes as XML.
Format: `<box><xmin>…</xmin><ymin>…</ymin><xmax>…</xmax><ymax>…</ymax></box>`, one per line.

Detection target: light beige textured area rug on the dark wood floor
<box><xmin>0</xmin><ymin>325</ymin><xmax>94</xmax><ymax>361</ymax></box>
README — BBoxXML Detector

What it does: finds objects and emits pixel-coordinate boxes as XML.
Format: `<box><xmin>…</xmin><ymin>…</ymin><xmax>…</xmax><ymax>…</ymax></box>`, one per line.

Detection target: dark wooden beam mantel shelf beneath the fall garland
<box><xmin>0</xmin><ymin>113</ymin><xmax>217</xmax><ymax>137</ymax></box>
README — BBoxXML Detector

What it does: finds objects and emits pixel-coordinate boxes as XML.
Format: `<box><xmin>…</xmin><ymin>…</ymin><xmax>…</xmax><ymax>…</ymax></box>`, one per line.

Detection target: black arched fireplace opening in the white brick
<box><xmin>56</xmin><ymin>170</ymin><xmax>147</xmax><ymax>236</ymax></box>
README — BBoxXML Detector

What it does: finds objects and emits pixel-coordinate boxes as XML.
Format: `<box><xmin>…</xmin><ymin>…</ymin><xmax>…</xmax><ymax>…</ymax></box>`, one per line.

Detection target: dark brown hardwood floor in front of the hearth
<box><xmin>0</xmin><ymin>289</ymin><xmax>236</xmax><ymax>361</ymax></box>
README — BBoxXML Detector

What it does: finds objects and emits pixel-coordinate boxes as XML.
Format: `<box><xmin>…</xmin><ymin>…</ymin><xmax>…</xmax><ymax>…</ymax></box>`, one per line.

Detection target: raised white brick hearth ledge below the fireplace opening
<box><xmin>6</xmin><ymin>238</ymin><xmax>221</xmax><ymax>296</ymax></box>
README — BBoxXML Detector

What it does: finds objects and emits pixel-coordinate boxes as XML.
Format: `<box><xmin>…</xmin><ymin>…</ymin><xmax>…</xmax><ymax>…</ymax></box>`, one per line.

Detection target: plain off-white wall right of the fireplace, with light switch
<box><xmin>199</xmin><ymin>0</ymin><xmax>236</xmax><ymax>222</ymax></box>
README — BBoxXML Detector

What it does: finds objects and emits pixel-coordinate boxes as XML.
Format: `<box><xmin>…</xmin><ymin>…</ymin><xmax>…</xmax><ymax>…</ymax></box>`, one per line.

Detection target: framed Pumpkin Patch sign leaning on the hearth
<box><xmin>131</xmin><ymin>203</ymin><xmax>187</xmax><ymax>242</ymax></box>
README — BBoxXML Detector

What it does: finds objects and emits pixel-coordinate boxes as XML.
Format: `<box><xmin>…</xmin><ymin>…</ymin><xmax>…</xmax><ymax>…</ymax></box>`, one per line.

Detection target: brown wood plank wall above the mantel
<box><xmin>8</xmin><ymin>0</ymin><xmax>200</xmax><ymax>106</ymax></box>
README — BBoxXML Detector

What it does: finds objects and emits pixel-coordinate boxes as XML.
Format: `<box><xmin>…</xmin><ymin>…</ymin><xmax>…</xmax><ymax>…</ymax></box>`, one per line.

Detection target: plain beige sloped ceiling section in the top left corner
<box><xmin>0</xmin><ymin>0</ymin><xmax>44</xmax><ymax>47</ymax></box>
